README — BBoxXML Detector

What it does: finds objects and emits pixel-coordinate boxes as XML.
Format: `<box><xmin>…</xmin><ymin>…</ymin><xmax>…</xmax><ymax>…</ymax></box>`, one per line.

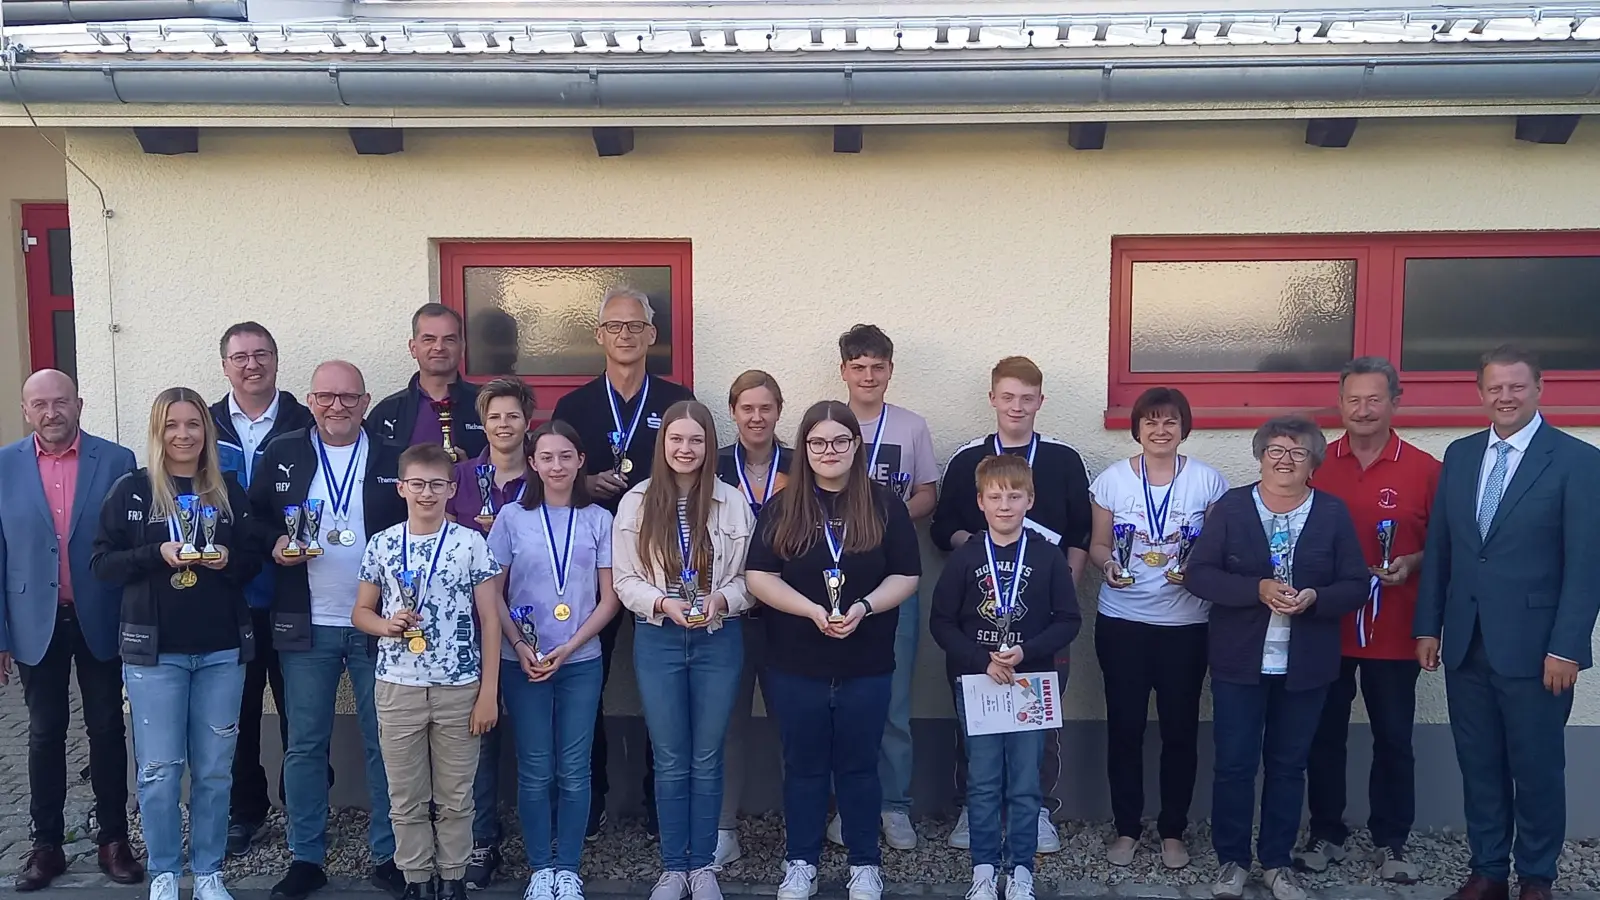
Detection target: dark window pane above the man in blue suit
<box><xmin>1400</xmin><ymin>256</ymin><xmax>1600</xmax><ymax>372</ymax></box>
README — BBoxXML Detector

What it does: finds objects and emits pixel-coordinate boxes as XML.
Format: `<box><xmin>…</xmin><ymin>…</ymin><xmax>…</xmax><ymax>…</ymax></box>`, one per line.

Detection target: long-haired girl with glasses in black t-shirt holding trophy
<box><xmin>746</xmin><ymin>400</ymin><xmax>922</xmax><ymax>900</ymax></box>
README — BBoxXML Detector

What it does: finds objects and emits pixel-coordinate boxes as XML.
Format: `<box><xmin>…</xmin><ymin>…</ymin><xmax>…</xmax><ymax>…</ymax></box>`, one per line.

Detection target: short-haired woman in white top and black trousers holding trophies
<box><xmin>1090</xmin><ymin>388</ymin><xmax>1227</xmax><ymax>870</ymax></box>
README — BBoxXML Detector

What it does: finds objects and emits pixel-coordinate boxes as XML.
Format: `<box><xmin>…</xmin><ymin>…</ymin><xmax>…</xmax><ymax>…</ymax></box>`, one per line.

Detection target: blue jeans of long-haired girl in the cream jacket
<box><xmin>634</xmin><ymin>618</ymin><xmax>744</xmax><ymax>871</ymax></box>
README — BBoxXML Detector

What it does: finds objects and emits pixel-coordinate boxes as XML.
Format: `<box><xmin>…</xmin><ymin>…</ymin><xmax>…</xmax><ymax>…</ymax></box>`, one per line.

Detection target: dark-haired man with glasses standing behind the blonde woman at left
<box><xmin>211</xmin><ymin>322</ymin><xmax>315</xmax><ymax>857</ymax></box>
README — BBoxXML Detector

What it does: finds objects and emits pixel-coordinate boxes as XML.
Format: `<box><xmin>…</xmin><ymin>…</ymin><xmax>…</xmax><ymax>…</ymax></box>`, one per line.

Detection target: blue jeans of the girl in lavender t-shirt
<box><xmin>502</xmin><ymin>657</ymin><xmax>603</xmax><ymax>873</ymax></box>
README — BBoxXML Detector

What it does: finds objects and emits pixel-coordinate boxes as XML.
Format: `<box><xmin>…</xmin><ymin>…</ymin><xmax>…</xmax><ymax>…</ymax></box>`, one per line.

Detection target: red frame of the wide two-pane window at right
<box><xmin>1106</xmin><ymin>232</ymin><xmax>1600</xmax><ymax>429</ymax></box>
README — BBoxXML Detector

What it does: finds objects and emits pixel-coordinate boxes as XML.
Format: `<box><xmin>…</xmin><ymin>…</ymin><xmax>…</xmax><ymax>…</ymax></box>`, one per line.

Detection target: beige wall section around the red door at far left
<box><xmin>0</xmin><ymin>128</ymin><xmax>67</xmax><ymax>444</ymax></box>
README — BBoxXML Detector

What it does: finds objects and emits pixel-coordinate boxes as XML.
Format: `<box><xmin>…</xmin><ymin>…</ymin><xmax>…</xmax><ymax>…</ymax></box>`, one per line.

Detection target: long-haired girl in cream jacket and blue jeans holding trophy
<box><xmin>613</xmin><ymin>400</ymin><xmax>754</xmax><ymax>900</ymax></box>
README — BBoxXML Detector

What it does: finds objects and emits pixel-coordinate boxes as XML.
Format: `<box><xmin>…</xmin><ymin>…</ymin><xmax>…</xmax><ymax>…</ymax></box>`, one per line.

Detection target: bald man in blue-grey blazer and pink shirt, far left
<box><xmin>0</xmin><ymin>368</ymin><xmax>144</xmax><ymax>890</ymax></box>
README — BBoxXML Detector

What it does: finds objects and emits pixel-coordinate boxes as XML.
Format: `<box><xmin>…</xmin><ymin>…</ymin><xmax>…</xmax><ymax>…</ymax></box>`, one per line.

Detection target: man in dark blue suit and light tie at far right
<box><xmin>1414</xmin><ymin>346</ymin><xmax>1600</xmax><ymax>900</ymax></box>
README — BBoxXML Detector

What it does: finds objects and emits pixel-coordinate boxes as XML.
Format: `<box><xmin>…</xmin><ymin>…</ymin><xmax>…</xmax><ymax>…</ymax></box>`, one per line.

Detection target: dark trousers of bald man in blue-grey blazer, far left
<box><xmin>18</xmin><ymin>607</ymin><xmax>128</xmax><ymax>846</ymax></box>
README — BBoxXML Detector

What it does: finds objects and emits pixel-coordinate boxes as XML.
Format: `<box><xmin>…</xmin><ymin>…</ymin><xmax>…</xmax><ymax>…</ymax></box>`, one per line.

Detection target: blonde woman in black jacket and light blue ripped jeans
<box><xmin>91</xmin><ymin>381</ymin><xmax>261</xmax><ymax>900</ymax></box>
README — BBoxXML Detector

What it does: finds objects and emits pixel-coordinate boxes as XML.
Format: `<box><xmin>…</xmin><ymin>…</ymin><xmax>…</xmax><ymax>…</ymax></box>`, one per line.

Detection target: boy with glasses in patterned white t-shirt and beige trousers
<box><xmin>350</xmin><ymin>444</ymin><xmax>502</xmax><ymax>900</ymax></box>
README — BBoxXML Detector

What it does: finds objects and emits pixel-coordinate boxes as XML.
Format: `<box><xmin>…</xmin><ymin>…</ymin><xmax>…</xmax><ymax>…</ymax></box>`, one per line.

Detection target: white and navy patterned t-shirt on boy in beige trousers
<box><xmin>362</xmin><ymin>522</ymin><xmax>501</xmax><ymax>687</ymax></box>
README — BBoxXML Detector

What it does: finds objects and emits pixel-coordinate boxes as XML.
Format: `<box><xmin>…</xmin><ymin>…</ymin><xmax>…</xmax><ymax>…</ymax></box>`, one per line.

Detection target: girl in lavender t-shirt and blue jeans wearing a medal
<box><xmin>490</xmin><ymin>420</ymin><xmax>621</xmax><ymax>900</ymax></box>
